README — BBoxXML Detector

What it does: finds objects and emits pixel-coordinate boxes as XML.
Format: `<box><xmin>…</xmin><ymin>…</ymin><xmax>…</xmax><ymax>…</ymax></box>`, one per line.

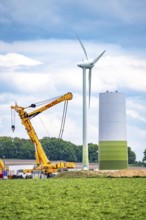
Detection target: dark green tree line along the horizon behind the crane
<box><xmin>0</xmin><ymin>137</ymin><xmax>136</xmax><ymax>164</ymax></box>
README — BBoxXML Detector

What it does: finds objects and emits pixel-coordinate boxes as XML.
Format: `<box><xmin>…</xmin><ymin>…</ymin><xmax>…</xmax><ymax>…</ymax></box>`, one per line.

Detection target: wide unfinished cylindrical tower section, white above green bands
<box><xmin>98</xmin><ymin>91</ymin><xmax>128</xmax><ymax>170</ymax></box>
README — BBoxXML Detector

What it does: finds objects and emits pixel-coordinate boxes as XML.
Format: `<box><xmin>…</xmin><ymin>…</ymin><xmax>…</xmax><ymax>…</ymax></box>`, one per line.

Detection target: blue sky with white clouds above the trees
<box><xmin>0</xmin><ymin>0</ymin><xmax>146</xmax><ymax>161</ymax></box>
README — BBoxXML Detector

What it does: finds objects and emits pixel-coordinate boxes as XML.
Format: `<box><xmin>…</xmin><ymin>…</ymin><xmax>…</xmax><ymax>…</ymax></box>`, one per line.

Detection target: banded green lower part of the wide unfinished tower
<box><xmin>98</xmin><ymin>141</ymin><xmax>128</xmax><ymax>170</ymax></box>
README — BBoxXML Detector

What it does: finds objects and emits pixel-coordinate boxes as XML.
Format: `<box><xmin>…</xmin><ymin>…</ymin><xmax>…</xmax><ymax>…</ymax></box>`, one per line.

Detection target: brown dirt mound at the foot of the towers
<box><xmin>55</xmin><ymin>169</ymin><xmax>146</xmax><ymax>178</ymax></box>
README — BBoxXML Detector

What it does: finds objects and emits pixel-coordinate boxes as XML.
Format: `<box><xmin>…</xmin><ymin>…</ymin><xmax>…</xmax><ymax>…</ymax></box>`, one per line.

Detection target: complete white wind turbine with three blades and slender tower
<box><xmin>76</xmin><ymin>35</ymin><xmax>105</xmax><ymax>170</ymax></box>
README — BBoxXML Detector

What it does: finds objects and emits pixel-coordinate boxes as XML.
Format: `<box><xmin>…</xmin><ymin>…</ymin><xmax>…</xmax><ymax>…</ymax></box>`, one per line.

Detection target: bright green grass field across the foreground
<box><xmin>0</xmin><ymin>178</ymin><xmax>146</xmax><ymax>220</ymax></box>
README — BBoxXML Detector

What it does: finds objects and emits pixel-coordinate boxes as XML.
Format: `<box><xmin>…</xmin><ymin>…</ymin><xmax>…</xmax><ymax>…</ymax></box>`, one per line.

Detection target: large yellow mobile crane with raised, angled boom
<box><xmin>11</xmin><ymin>93</ymin><xmax>74</xmax><ymax>177</ymax></box>
